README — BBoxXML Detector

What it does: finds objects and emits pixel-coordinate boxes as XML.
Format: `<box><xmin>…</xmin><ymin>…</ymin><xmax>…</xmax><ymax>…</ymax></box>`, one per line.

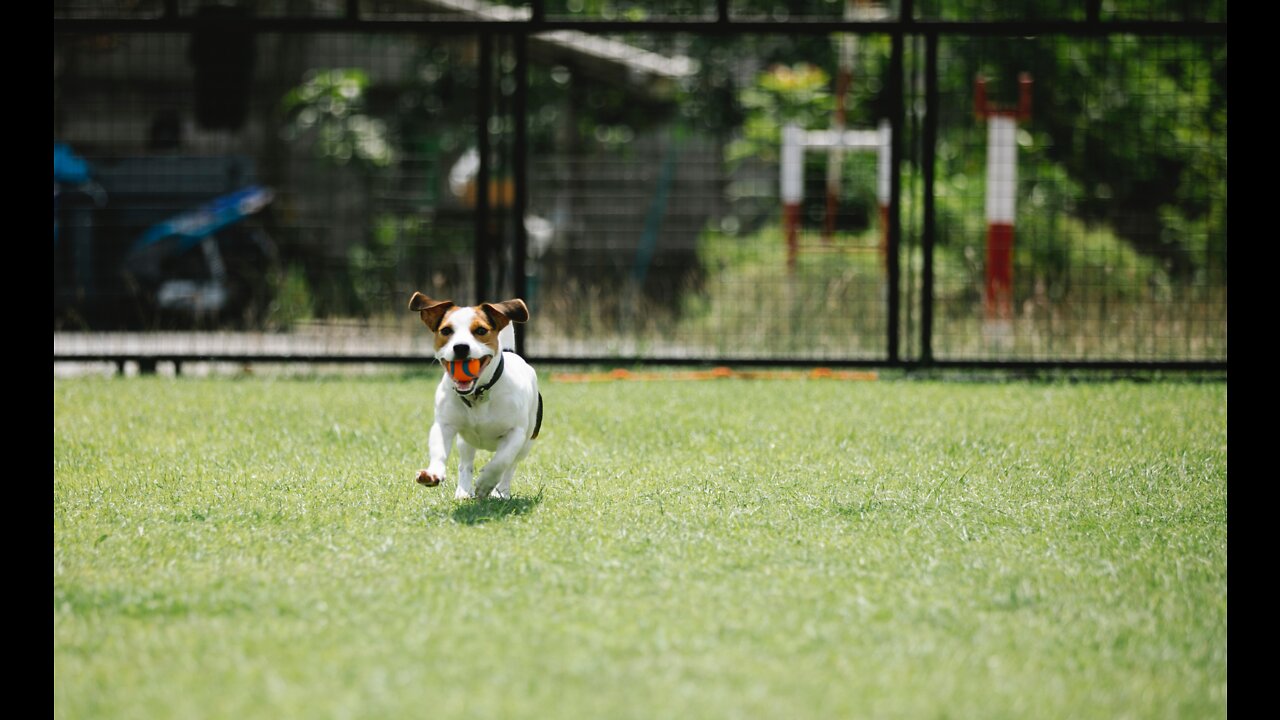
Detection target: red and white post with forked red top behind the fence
<box><xmin>974</xmin><ymin>73</ymin><xmax>1032</xmax><ymax>324</ymax></box>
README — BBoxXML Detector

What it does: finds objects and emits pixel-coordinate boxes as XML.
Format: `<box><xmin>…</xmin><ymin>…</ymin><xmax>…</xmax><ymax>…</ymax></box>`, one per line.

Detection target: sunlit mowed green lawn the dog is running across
<box><xmin>54</xmin><ymin>373</ymin><xmax>1228</xmax><ymax>720</ymax></box>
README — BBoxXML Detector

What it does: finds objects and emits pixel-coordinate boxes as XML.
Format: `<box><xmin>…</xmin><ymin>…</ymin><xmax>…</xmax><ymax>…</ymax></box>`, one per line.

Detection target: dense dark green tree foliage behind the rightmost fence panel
<box><xmin>940</xmin><ymin>36</ymin><xmax>1226</xmax><ymax>279</ymax></box>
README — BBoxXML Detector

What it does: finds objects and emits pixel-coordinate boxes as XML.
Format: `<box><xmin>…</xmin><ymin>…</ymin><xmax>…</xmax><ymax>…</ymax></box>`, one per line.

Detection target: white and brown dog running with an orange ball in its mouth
<box><xmin>408</xmin><ymin>292</ymin><xmax>543</xmax><ymax>500</ymax></box>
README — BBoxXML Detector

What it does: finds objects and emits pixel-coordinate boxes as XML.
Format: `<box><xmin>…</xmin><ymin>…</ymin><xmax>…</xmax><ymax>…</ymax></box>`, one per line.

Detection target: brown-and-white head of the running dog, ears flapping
<box><xmin>408</xmin><ymin>292</ymin><xmax>529</xmax><ymax>395</ymax></box>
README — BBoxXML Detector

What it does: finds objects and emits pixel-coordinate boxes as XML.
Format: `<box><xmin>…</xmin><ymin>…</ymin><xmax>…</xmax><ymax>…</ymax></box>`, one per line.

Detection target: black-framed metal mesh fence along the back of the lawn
<box><xmin>54</xmin><ymin>0</ymin><xmax>1226</xmax><ymax>365</ymax></box>
